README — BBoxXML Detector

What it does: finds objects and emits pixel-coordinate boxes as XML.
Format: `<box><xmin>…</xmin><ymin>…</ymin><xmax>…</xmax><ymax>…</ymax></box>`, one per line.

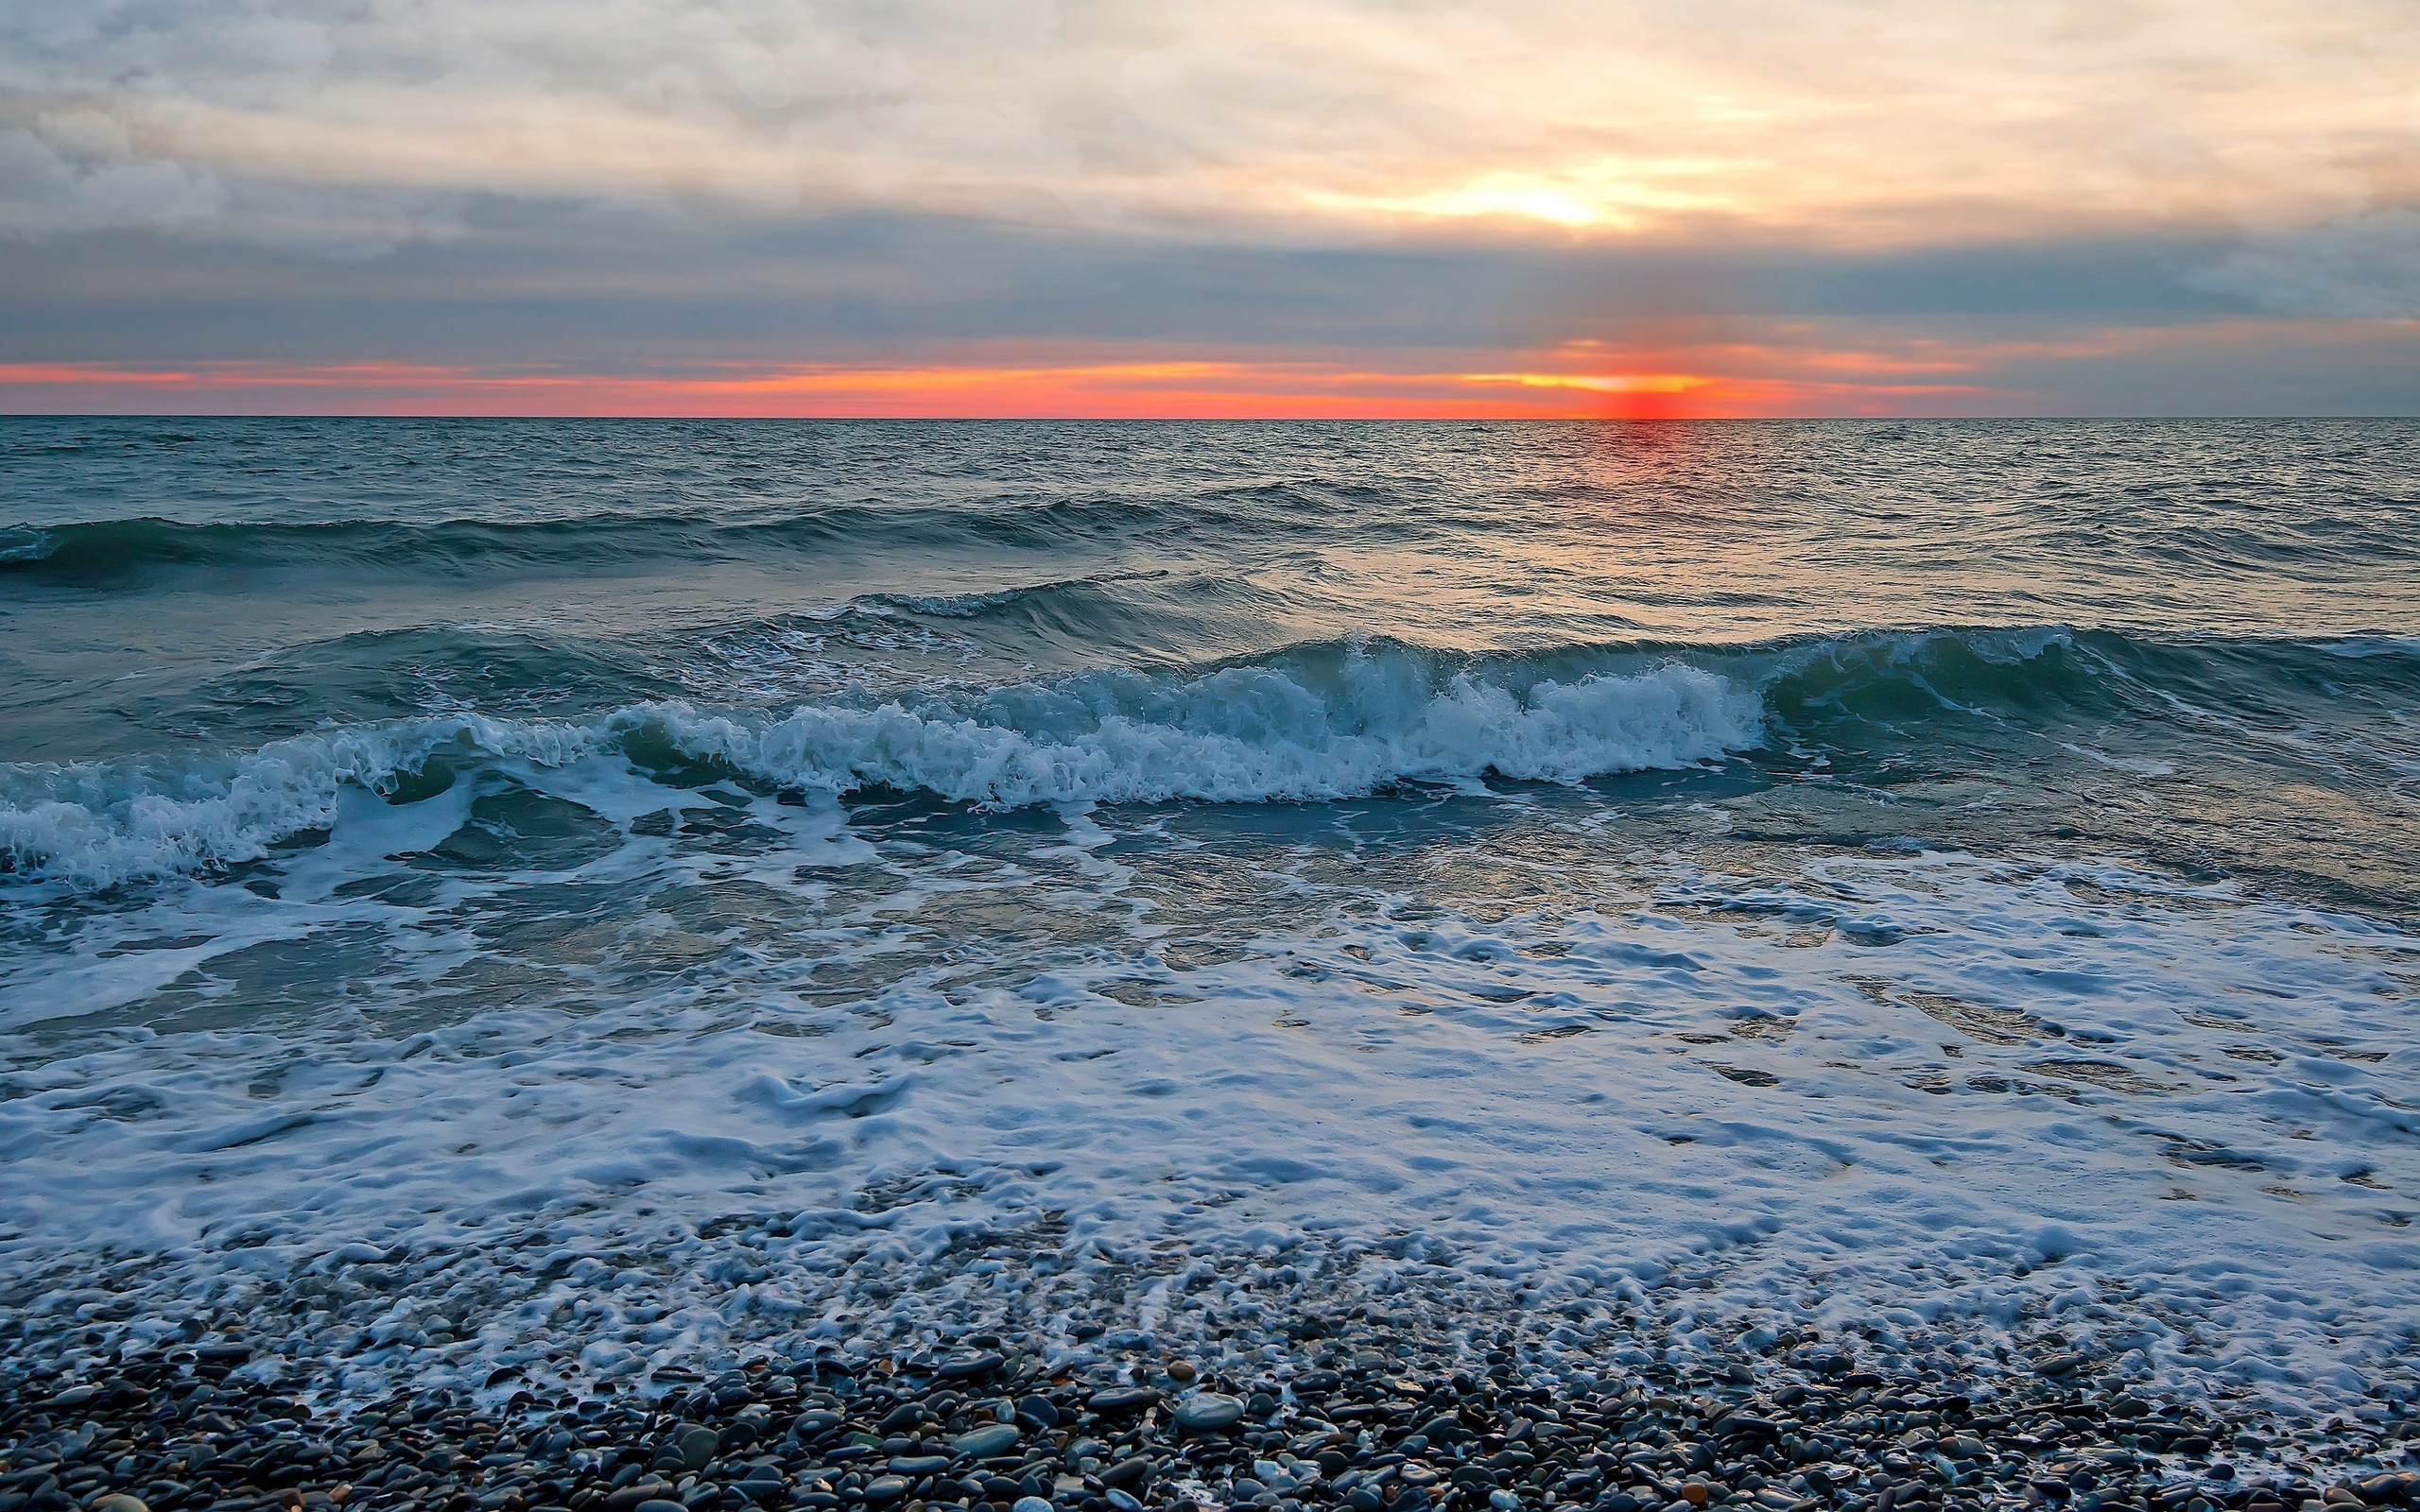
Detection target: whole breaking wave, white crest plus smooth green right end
<box><xmin>0</xmin><ymin>624</ymin><xmax>2420</xmax><ymax>888</ymax></box>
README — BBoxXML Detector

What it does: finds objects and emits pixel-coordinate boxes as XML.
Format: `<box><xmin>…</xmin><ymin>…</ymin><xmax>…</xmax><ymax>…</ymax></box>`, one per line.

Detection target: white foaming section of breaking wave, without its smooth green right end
<box><xmin>0</xmin><ymin>644</ymin><xmax>1764</xmax><ymax>890</ymax></box>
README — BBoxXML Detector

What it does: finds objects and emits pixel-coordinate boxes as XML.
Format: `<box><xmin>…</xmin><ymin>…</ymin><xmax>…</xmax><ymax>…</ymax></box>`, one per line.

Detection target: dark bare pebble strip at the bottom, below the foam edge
<box><xmin>0</xmin><ymin>1328</ymin><xmax>2420</xmax><ymax>1512</ymax></box>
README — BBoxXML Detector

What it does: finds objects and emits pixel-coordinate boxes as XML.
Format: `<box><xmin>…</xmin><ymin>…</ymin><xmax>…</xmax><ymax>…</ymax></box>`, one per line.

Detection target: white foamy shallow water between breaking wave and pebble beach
<box><xmin>0</xmin><ymin>760</ymin><xmax>2420</xmax><ymax>1400</ymax></box>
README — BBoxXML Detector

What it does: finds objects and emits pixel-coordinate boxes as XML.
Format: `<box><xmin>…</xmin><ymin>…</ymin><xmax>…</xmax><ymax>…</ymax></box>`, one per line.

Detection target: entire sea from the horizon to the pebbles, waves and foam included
<box><xmin>0</xmin><ymin>419</ymin><xmax>2420</xmax><ymax>1405</ymax></box>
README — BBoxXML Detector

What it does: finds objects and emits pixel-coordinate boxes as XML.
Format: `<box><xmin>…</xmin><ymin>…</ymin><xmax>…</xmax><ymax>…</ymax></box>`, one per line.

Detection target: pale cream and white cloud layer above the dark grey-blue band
<box><xmin>0</xmin><ymin>0</ymin><xmax>2420</xmax><ymax>245</ymax></box>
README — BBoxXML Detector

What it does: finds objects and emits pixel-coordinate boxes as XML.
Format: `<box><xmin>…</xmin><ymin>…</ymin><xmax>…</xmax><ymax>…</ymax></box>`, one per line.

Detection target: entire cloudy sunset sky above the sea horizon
<box><xmin>0</xmin><ymin>0</ymin><xmax>2420</xmax><ymax>416</ymax></box>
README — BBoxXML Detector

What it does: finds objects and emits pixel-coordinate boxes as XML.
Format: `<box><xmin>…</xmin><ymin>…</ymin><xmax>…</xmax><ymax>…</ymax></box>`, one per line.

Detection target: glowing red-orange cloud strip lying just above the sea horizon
<box><xmin>0</xmin><ymin>319</ymin><xmax>2420</xmax><ymax>419</ymax></box>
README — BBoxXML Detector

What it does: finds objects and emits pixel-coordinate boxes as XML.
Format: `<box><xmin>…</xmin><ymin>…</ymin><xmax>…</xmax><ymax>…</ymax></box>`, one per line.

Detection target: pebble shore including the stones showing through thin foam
<box><xmin>0</xmin><ymin>1246</ymin><xmax>2420</xmax><ymax>1512</ymax></box>
